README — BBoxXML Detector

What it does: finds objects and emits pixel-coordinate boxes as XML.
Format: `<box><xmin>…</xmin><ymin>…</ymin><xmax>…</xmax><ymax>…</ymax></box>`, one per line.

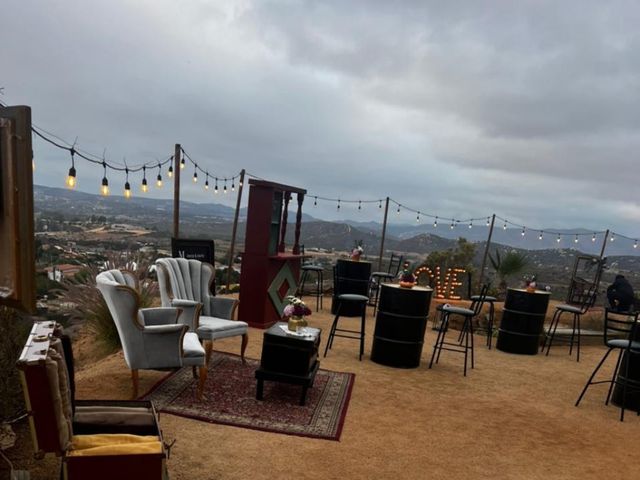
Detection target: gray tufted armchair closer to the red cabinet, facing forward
<box><xmin>156</xmin><ymin>258</ymin><xmax>249</xmax><ymax>364</ymax></box>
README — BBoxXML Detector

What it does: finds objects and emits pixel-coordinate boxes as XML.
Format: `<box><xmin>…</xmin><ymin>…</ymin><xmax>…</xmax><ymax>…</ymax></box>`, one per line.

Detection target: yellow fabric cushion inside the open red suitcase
<box><xmin>67</xmin><ymin>433</ymin><xmax>162</xmax><ymax>456</ymax></box>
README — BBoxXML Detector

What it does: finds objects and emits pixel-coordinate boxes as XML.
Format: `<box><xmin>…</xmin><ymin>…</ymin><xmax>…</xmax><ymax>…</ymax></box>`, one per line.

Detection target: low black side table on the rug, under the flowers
<box><xmin>255</xmin><ymin>322</ymin><xmax>322</xmax><ymax>406</ymax></box>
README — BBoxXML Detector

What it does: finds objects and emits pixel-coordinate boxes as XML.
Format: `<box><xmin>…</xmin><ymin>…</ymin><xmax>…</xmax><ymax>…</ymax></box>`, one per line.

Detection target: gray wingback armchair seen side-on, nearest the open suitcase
<box><xmin>96</xmin><ymin>270</ymin><xmax>207</xmax><ymax>398</ymax></box>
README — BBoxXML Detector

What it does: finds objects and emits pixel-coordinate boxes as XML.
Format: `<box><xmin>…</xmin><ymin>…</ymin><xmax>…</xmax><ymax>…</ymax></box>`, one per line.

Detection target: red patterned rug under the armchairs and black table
<box><xmin>143</xmin><ymin>352</ymin><xmax>355</xmax><ymax>440</ymax></box>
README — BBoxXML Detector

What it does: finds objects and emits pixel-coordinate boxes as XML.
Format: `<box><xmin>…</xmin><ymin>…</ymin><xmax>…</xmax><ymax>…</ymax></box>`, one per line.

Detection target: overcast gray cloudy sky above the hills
<box><xmin>0</xmin><ymin>0</ymin><xmax>640</xmax><ymax>244</ymax></box>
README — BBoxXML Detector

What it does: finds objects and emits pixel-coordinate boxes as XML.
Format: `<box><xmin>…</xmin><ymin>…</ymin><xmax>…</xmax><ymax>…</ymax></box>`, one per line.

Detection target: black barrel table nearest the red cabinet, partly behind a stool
<box><xmin>331</xmin><ymin>260</ymin><xmax>371</xmax><ymax>317</ymax></box>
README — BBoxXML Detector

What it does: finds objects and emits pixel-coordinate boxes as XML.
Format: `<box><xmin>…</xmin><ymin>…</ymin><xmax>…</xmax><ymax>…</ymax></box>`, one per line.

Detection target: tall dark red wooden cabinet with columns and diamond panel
<box><xmin>238</xmin><ymin>180</ymin><xmax>307</xmax><ymax>328</ymax></box>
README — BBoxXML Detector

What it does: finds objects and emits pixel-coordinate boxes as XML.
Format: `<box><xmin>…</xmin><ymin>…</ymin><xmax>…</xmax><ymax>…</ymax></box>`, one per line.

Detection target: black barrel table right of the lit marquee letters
<box><xmin>496</xmin><ymin>288</ymin><xmax>551</xmax><ymax>355</ymax></box>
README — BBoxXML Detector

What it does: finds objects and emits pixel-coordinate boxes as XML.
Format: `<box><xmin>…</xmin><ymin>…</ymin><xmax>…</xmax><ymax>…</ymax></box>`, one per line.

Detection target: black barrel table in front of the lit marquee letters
<box><xmin>371</xmin><ymin>283</ymin><xmax>433</xmax><ymax>368</ymax></box>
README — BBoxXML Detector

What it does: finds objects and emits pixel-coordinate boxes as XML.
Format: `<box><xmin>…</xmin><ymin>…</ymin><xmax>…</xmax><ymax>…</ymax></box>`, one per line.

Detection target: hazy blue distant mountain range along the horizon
<box><xmin>34</xmin><ymin>185</ymin><xmax>640</xmax><ymax>256</ymax></box>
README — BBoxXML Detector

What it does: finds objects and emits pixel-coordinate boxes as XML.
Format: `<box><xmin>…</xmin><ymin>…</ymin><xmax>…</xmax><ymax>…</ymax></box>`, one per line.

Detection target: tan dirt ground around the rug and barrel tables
<box><xmin>2</xmin><ymin>298</ymin><xmax>640</xmax><ymax>480</ymax></box>
